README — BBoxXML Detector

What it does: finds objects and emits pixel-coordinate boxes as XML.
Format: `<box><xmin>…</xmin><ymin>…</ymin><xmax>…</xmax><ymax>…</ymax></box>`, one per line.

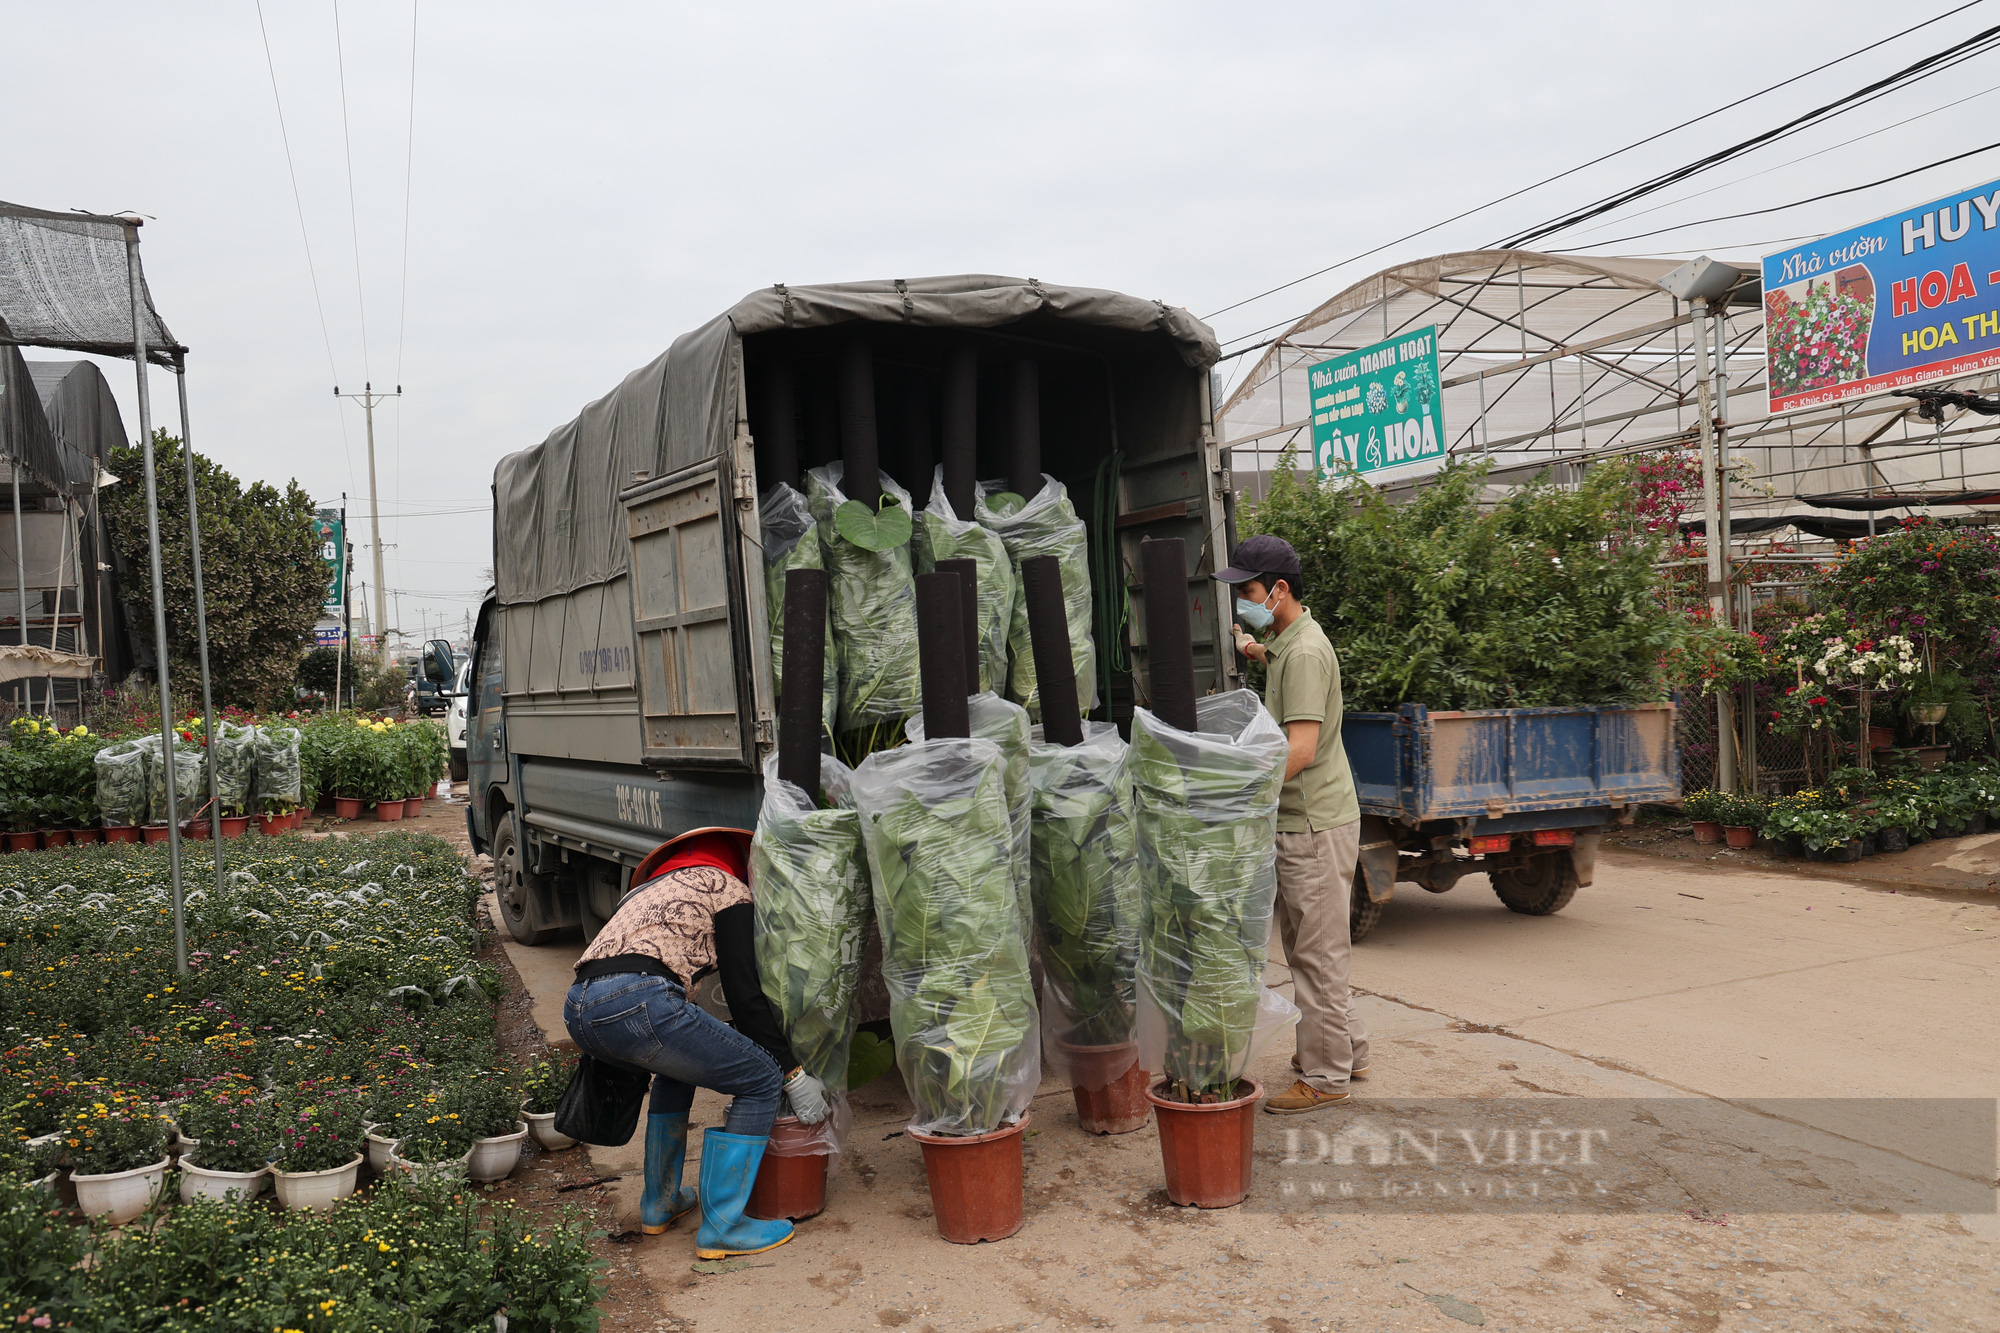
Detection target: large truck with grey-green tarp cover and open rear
<box><xmin>466</xmin><ymin>274</ymin><xmax>1240</xmax><ymax>943</ymax></box>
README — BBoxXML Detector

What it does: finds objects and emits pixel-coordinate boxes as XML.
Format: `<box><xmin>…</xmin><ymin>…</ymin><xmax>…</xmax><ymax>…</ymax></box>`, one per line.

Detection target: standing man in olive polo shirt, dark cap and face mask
<box><xmin>1216</xmin><ymin>536</ymin><xmax>1368</xmax><ymax>1115</ymax></box>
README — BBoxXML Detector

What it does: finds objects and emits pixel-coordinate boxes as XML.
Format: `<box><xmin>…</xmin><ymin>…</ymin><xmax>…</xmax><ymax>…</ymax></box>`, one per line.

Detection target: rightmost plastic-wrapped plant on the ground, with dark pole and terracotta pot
<box><xmin>1126</xmin><ymin>538</ymin><xmax>1298</xmax><ymax>1207</ymax></box>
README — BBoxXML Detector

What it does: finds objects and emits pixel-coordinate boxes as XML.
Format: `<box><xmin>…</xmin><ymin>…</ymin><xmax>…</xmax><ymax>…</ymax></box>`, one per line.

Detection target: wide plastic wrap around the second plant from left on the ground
<box><xmin>854</xmin><ymin>737</ymin><xmax>1042</xmax><ymax>1135</ymax></box>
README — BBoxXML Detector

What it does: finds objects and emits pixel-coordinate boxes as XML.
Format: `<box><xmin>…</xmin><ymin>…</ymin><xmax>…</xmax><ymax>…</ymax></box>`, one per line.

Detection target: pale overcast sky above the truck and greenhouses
<box><xmin>15</xmin><ymin>0</ymin><xmax>2000</xmax><ymax>632</ymax></box>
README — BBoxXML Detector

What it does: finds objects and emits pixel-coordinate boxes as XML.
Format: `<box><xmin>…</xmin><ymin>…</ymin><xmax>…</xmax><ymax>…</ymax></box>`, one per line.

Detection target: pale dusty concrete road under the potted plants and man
<box><xmin>488</xmin><ymin>853</ymin><xmax>2000</xmax><ymax>1333</ymax></box>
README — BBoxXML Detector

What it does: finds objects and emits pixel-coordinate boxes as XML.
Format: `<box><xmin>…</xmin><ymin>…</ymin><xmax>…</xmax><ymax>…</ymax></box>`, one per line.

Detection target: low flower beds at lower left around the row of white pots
<box><xmin>0</xmin><ymin>835</ymin><xmax>594</xmax><ymax>1329</ymax></box>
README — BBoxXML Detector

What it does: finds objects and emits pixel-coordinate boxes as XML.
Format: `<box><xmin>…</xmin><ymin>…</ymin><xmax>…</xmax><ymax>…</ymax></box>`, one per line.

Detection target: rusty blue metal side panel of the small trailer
<box><xmin>1340</xmin><ymin>705</ymin><xmax>1680</xmax><ymax>825</ymax></box>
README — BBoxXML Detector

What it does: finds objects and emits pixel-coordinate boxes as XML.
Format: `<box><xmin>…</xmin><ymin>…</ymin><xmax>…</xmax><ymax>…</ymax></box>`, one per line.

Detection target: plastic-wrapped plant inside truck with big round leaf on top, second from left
<box><xmin>806</xmin><ymin>462</ymin><xmax>922</xmax><ymax>733</ymax></box>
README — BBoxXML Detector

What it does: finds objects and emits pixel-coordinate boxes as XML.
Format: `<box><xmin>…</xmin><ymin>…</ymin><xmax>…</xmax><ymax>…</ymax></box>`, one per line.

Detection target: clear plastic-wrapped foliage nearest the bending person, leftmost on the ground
<box><xmin>750</xmin><ymin>755</ymin><xmax>872</xmax><ymax>1155</ymax></box>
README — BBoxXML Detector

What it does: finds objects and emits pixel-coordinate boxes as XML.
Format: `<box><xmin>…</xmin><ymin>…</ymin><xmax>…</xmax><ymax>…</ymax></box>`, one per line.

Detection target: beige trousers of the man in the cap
<box><xmin>1276</xmin><ymin>819</ymin><xmax>1368</xmax><ymax>1093</ymax></box>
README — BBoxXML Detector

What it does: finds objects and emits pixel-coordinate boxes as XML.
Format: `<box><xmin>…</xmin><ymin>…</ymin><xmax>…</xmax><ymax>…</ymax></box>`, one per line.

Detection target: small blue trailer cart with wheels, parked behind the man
<box><xmin>1340</xmin><ymin>703</ymin><xmax>1680</xmax><ymax>941</ymax></box>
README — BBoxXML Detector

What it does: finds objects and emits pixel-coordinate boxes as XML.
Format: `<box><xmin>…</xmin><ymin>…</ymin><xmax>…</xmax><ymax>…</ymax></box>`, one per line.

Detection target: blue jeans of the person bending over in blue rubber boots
<box><xmin>562</xmin><ymin>973</ymin><xmax>784</xmax><ymax>1139</ymax></box>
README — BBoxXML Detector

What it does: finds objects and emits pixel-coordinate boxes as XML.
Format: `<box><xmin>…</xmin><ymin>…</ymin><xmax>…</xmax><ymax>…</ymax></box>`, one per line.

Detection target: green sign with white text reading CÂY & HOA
<box><xmin>1308</xmin><ymin>324</ymin><xmax>1444</xmax><ymax>476</ymax></box>
